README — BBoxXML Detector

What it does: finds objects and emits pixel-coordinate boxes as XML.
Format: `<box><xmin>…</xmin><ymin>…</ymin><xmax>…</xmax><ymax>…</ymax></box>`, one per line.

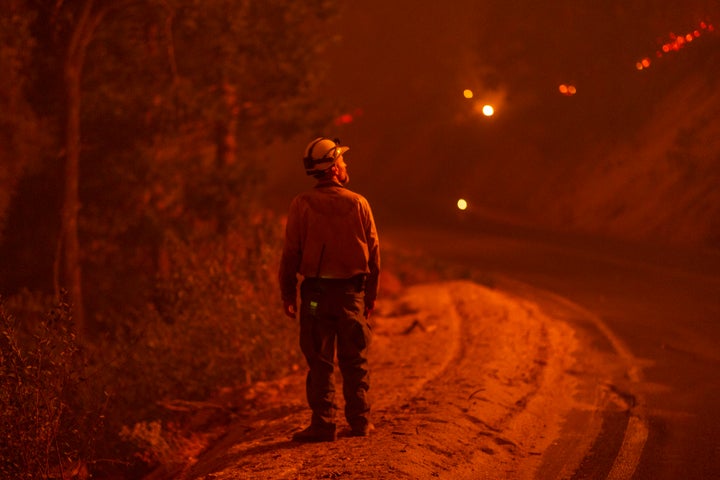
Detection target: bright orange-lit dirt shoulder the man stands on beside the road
<box><xmin>165</xmin><ymin>281</ymin><xmax>623</xmax><ymax>480</ymax></box>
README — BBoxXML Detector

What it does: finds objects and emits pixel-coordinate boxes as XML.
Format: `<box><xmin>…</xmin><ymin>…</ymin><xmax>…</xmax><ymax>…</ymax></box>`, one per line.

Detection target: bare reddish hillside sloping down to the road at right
<box><xmin>532</xmin><ymin>71</ymin><xmax>720</xmax><ymax>248</ymax></box>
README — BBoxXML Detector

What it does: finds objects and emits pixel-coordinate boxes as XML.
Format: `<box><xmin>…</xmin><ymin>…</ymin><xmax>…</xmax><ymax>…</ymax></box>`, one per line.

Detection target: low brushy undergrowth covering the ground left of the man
<box><xmin>0</xmin><ymin>213</ymin><xmax>301</xmax><ymax>478</ymax></box>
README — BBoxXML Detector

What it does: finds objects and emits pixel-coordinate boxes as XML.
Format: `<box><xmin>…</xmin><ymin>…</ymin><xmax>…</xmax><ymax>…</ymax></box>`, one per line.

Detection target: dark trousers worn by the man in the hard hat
<box><xmin>300</xmin><ymin>277</ymin><xmax>371</xmax><ymax>428</ymax></box>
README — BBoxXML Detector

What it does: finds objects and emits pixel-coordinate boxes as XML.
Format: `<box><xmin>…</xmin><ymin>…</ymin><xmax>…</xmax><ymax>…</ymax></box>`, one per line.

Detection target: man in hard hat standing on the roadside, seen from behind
<box><xmin>279</xmin><ymin>137</ymin><xmax>380</xmax><ymax>442</ymax></box>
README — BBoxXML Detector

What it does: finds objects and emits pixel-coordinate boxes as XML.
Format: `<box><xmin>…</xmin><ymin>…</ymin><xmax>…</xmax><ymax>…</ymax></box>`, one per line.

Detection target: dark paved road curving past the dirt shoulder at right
<box><xmin>383</xmin><ymin>218</ymin><xmax>720</xmax><ymax>480</ymax></box>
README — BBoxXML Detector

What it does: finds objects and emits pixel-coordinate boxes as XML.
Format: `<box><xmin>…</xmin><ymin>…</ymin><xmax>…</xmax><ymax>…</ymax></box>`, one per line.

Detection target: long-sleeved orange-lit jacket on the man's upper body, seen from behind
<box><xmin>279</xmin><ymin>181</ymin><xmax>380</xmax><ymax>303</ymax></box>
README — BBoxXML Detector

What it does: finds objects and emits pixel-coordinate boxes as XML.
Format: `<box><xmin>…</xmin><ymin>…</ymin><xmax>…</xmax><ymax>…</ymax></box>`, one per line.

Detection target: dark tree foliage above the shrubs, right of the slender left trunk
<box><xmin>74</xmin><ymin>0</ymin><xmax>336</xmax><ymax>320</ymax></box>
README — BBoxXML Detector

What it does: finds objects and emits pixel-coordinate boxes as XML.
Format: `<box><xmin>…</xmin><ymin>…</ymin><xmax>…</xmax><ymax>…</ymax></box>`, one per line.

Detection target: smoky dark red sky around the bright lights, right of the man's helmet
<box><xmin>268</xmin><ymin>0</ymin><xmax>720</xmax><ymax>220</ymax></box>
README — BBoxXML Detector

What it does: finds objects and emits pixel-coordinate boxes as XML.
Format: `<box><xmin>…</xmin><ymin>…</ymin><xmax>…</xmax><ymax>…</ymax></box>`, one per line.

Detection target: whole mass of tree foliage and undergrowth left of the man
<box><xmin>0</xmin><ymin>0</ymin><xmax>344</xmax><ymax>478</ymax></box>
